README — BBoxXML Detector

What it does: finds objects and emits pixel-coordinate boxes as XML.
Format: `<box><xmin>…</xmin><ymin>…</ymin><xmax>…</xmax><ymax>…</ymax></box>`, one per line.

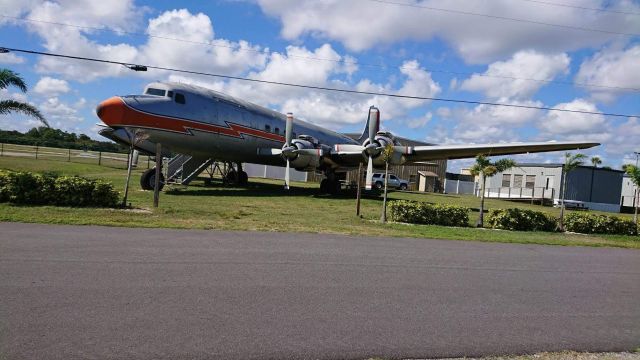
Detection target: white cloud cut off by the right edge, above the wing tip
<box><xmin>576</xmin><ymin>45</ymin><xmax>640</xmax><ymax>101</ymax></box>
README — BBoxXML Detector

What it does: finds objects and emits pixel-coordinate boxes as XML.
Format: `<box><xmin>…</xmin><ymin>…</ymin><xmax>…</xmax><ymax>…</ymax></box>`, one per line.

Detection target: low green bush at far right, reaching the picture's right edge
<box><xmin>564</xmin><ymin>212</ymin><xmax>638</xmax><ymax>235</ymax></box>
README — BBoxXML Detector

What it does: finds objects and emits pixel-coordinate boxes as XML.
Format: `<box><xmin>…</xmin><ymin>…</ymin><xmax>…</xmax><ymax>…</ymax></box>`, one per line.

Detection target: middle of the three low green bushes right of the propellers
<box><xmin>487</xmin><ymin>208</ymin><xmax>557</xmax><ymax>231</ymax></box>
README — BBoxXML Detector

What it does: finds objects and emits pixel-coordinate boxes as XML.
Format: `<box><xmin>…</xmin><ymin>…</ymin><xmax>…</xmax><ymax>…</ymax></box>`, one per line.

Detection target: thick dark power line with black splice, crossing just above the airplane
<box><xmin>0</xmin><ymin>47</ymin><xmax>640</xmax><ymax>117</ymax></box>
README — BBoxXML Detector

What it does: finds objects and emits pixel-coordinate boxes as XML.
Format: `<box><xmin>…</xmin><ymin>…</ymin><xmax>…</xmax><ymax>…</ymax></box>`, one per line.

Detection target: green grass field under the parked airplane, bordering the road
<box><xmin>0</xmin><ymin>156</ymin><xmax>640</xmax><ymax>248</ymax></box>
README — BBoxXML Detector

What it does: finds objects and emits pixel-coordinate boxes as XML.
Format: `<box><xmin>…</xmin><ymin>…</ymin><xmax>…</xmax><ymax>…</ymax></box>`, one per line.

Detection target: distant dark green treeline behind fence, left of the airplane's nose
<box><xmin>0</xmin><ymin>126</ymin><xmax>128</xmax><ymax>152</ymax></box>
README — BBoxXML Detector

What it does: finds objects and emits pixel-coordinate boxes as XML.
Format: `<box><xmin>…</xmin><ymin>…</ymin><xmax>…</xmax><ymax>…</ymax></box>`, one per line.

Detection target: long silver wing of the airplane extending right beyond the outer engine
<box><xmin>405</xmin><ymin>141</ymin><xmax>600</xmax><ymax>162</ymax></box>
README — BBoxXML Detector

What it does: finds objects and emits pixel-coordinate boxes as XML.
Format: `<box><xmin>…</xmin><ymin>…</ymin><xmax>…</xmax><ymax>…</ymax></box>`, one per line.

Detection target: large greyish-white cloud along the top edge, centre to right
<box><xmin>258</xmin><ymin>0</ymin><xmax>640</xmax><ymax>63</ymax></box>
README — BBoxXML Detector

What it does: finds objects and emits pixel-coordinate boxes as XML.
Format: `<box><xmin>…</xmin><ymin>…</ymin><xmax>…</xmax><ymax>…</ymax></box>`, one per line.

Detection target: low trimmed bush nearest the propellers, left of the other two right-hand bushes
<box><xmin>389</xmin><ymin>200</ymin><xmax>469</xmax><ymax>226</ymax></box>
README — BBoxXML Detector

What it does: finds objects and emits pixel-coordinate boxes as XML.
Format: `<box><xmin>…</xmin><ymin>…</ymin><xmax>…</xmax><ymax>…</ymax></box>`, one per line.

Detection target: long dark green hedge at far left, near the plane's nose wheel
<box><xmin>0</xmin><ymin>170</ymin><xmax>120</xmax><ymax>207</ymax></box>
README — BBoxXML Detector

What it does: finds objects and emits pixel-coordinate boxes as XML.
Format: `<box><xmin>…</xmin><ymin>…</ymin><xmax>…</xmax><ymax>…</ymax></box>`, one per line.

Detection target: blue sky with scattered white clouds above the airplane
<box><xmin>0</xmin><ymin>0</ymin><xmax>640</xmax><ymax>171</ymax></box>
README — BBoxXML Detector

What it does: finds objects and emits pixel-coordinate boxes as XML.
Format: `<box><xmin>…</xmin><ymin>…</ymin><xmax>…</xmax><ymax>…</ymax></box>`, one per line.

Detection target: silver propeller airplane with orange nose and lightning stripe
<box><xmin>96</xmin><ymin>82</ymin><xmax>600</xmax><ymax>194</ymax></box>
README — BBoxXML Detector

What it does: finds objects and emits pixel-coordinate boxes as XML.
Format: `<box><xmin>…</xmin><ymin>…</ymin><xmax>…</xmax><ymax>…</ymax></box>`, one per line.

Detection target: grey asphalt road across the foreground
<box><xmin>0</xmin><ymin>223</ymin><xmax>640</xmax><ymax>359</ymax></box>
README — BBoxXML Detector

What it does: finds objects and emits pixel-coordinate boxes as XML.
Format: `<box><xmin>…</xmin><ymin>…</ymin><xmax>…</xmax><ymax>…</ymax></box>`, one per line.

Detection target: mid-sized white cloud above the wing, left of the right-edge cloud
<box><xmin>460</xmin><ymin>50</ymin><xmax>570</xmax><ymax>99</ymax></box>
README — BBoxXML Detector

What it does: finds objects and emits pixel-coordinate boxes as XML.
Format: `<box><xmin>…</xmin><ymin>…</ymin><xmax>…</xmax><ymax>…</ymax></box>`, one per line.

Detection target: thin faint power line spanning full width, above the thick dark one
<box><xmin>0</xmin><ymin>14</ymin><xmax>640</xmax><ymax>91</ymax></box>
